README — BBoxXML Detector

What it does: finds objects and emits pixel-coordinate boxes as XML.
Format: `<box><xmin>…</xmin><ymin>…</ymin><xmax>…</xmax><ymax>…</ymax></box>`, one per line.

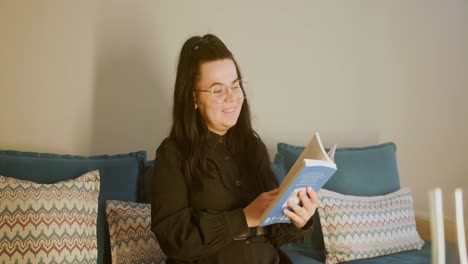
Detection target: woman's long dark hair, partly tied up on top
<box><xmin>168</xmin><ymin>34</ymin><xmax>266</xmax><ymax>184</ymax></box>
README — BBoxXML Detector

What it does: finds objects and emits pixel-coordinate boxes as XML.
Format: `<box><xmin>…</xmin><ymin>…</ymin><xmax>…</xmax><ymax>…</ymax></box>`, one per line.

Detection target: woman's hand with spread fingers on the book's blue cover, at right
<box><xmin>283</xmin><ymin>187</ymin><xmax>317</xmax><ymax>228</ymax></box>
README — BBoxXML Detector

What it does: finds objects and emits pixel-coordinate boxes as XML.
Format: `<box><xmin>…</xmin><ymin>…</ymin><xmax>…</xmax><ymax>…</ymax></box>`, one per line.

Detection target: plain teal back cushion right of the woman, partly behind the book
<box><xmin>273</xmin><ymin>143</ymin><xmax>400</xmax><ymax>255</ymax></box>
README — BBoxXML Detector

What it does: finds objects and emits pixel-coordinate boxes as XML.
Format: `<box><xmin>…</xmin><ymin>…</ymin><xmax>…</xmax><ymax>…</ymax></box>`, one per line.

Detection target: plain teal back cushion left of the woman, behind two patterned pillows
<box><xmin>0</xmin><ymin>150</ymin><xmax>146</xmax><ymax>263</ymax></box>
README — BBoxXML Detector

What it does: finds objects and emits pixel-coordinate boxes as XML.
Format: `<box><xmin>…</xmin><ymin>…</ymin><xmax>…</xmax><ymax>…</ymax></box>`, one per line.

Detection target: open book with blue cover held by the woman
<box><xmin>260</xmin><ymin>133</ymin><xmax>337</xmax><ymax>226</ymax></box>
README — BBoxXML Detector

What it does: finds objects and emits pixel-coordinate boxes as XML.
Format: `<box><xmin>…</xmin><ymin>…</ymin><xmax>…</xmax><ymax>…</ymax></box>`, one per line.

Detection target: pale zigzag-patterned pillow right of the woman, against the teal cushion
<box><xmin>318</xmin><ymin>188</ymin><xmax>424</xmax><ymax>264</ymax></box>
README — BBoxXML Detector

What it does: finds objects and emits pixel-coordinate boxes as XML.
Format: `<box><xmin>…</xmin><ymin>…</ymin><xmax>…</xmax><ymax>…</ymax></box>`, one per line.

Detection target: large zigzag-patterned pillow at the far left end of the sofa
<box><xmin>0</xmin><ymin>171</ymin><xmax>99</xmax><ymax>263</ymax></box>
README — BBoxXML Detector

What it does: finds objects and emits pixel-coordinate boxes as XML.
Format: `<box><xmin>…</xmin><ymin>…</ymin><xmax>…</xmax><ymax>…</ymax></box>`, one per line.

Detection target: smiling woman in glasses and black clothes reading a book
<box><xmin>151</xmin><ymin>34</ymin><xmax>317</xmax><ymax>263</ymax></box>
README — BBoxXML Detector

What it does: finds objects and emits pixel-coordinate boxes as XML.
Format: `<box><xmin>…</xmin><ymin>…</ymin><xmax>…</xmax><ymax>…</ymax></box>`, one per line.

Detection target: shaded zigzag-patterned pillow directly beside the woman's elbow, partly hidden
<box><xmin>106</xmin><ymin>200</ymin><xmax>166</xmax><ymax>263</ymax></box>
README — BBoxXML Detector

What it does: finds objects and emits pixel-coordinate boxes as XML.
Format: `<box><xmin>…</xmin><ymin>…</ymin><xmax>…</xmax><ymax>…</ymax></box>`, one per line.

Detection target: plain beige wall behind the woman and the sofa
<box><xmin>0</xmin><ymin>0</ymin><xmax>468</xmax><ymax>220</ymax></box>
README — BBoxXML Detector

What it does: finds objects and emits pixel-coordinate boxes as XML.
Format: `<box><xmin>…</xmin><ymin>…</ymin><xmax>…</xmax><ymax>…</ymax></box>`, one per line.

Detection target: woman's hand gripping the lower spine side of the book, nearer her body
<box><xmin>244</xmin><ymin>189</ymin><xmax>279</xmax><ymax>227</ymax></box>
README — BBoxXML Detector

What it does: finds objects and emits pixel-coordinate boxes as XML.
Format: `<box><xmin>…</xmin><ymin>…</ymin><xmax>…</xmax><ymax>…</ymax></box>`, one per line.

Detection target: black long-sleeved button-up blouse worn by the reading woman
<box><xmin>151</xmin><ymin>132</ymin><xmax>312</xmax><ymax>264</ymax></box>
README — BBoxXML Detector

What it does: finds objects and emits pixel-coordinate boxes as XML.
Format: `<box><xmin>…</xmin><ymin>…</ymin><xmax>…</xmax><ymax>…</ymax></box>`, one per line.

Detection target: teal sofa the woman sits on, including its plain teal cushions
<box><xmin>0</xmin><ymin>143</ymin><xmax>456</xmax><ymax>264</ymax></box>
